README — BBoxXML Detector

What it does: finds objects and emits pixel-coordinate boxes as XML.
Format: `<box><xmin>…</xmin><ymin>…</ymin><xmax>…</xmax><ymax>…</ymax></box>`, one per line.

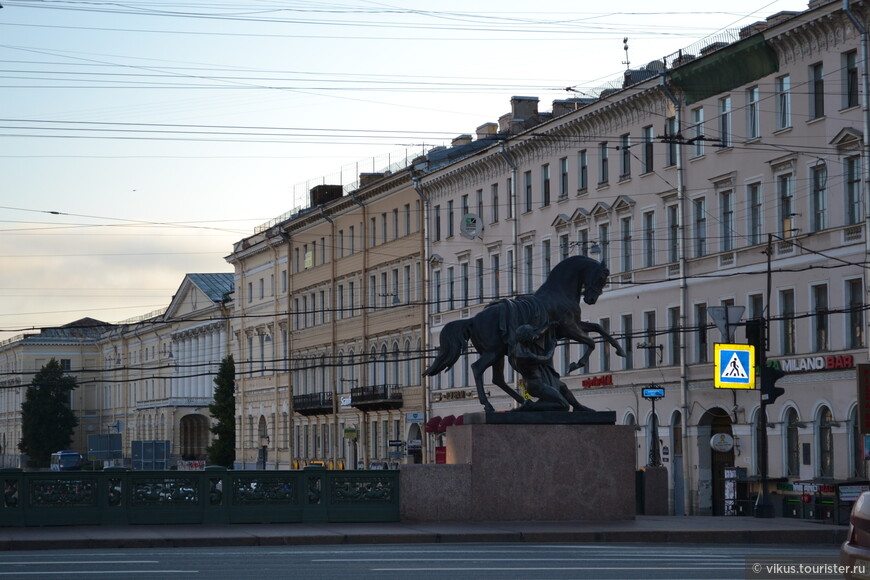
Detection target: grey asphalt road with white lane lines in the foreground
<box><xmin>0</xmin><ymin>544</ymin><xmax>842</xmax><ymax>580</ymax></box>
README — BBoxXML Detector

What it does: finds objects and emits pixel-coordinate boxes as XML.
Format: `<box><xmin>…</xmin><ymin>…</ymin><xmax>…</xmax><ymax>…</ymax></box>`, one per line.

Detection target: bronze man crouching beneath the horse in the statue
<box><xmin>508</xmin><ymin>323</ymin><xmax>592</xmax><ymax>411</ymax></box>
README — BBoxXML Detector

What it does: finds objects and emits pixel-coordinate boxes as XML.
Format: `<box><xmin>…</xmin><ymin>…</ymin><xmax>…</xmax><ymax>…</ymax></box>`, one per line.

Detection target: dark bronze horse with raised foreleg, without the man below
<box><xmin>423</xmin><ymin>256</ymin><xmax>625</xmax><ymax>413</ymax></box>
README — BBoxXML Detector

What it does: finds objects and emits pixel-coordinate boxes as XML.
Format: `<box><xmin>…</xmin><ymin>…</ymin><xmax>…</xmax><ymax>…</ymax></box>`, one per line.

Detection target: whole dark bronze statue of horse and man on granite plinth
<box><xmin>423</xmin><ymin>256</ymin><xmax>625</xmax><ymax>413</ymax></box>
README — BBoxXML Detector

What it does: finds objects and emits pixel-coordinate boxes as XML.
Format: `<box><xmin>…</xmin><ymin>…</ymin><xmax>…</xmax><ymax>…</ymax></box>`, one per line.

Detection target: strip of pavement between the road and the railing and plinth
<box><xmin>0</xmin><ymin>516</ymin><xmax>847</xmax><ymax>551</ymax></box>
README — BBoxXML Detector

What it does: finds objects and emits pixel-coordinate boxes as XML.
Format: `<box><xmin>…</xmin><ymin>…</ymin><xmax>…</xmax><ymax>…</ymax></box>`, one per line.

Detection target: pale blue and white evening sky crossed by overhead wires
<box><xmin>0</xmin><ymin>0</ymin><xmax>807</xmax><ymax>340</ymax></box>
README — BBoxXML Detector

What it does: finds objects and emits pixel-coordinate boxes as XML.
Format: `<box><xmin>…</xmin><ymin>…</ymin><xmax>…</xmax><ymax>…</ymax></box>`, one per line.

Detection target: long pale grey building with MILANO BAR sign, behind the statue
<box><xmin>419</xmin><ymin>2</ymin><xmax>868</xmax><ymax>514</ymax></box>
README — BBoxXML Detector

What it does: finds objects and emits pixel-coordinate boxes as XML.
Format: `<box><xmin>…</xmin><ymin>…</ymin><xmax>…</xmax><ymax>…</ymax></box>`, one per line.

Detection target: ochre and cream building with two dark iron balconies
<box><xmin>227</xmin><ymin>171</ymin><xmax>425</xmax><ymax>469</ymax></box>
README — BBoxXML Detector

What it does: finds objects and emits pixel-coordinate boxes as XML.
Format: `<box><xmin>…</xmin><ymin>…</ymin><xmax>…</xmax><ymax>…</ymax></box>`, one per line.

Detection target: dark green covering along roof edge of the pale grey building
<box><xmin>668</xmin><ymin>34</ymin><xmax>779</xmax><ymax>105</ymax></box>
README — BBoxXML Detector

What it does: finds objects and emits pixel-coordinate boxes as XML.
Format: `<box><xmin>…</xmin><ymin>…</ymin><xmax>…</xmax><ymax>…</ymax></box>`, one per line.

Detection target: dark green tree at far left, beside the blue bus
<box><xmin>18</xmin><ymin>359</ymin><xmax>79</xmax><ymax>467</ymax></box>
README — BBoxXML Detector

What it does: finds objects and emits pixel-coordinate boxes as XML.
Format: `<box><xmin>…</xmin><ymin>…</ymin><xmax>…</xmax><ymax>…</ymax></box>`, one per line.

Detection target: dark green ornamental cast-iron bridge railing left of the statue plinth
<box><xmin>0</xmin><ymin>467</ymin><xmax>399</xmax><ymax>526</ymax></box>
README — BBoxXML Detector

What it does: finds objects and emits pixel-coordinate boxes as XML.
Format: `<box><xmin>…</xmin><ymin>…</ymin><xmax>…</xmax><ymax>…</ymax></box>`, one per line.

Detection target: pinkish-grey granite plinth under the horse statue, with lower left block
<box><xmin>401</xmin><ymin>424</ymin><xmax>636</xmax><ymax>521</ymax></box>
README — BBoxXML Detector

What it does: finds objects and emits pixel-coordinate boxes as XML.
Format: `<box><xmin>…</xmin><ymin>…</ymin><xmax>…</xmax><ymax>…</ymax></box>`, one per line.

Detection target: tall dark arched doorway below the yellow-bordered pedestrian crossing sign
<box><xmin>697</xmin><ymin>407</ymin><xmax>734</xmax><ymax>516</ymax></box>
